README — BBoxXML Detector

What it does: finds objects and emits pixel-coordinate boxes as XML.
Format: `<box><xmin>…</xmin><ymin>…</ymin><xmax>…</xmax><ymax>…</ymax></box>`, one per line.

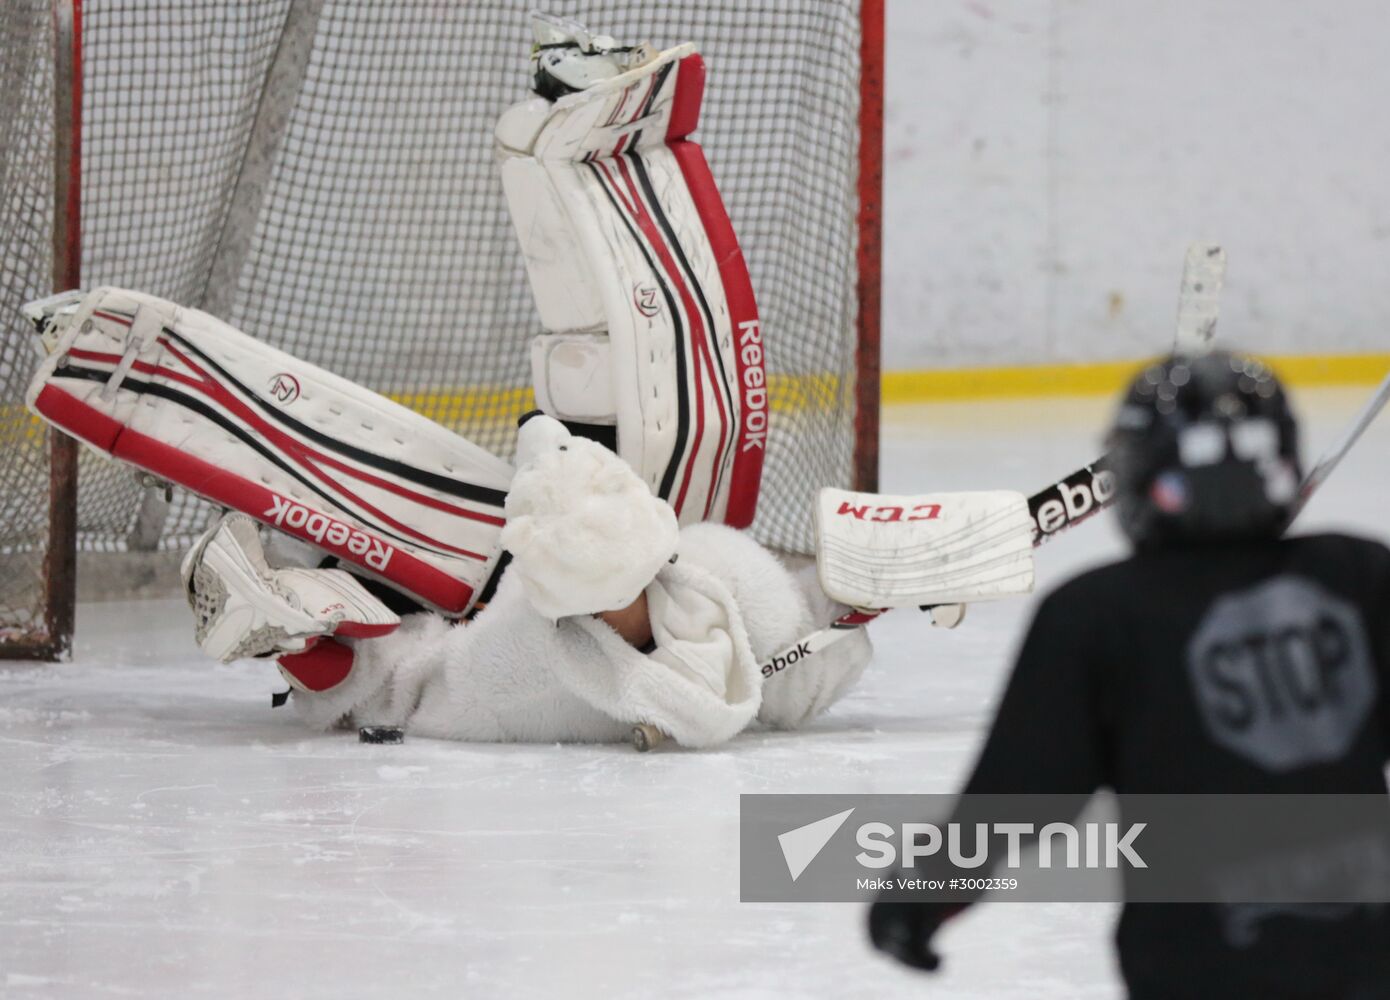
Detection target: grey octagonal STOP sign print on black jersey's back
<box><xmin>1187</xmin><ymin>576</ymin><xmax>1376</xmax><ymax>772</ymax></box>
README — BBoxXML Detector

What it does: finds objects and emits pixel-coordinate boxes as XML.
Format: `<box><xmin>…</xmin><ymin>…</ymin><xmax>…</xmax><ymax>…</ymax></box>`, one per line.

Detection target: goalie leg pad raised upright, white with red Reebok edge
<box><xmin>498</xmin><ymin>46</ymin><xmax>767</xmax><ymax>527</ymax></box>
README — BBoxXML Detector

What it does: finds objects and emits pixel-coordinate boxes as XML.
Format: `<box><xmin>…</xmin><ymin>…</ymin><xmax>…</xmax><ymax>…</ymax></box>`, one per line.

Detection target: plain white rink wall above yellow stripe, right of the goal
<box><xmin>884</xmin><ymin>0</ymin><xmax>1390</xmax><ymax>369</ymax></box>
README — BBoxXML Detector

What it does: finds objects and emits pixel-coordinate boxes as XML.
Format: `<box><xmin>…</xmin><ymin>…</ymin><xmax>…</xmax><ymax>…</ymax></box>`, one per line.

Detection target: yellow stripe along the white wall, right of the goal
<box><xmin>883</xmin><ymin>353</ymin><xmax>1390</xmax><ymax>403</ymax></box>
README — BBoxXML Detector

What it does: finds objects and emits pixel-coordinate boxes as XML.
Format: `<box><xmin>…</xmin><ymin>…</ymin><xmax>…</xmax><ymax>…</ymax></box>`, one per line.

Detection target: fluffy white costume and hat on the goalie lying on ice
<box><xmin>284</xmin><ymin>419</ymin><xmax>869</xmax><ymax>747</ymax></box>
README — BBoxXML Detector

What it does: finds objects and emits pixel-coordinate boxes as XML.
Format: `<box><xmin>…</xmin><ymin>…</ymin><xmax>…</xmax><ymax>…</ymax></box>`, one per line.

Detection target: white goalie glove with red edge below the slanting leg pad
<box><xmin>182</xmin><ymin>513</ymin><xmax>400</xmax><ymax>663</ymax></box>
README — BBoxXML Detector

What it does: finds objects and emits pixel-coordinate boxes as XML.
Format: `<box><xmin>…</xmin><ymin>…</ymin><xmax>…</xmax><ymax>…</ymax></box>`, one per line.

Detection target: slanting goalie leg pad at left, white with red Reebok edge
<box><xmin>26</xmin><ymin>288</ymin><xmax>512</xmax><ymax>615</ymax></box>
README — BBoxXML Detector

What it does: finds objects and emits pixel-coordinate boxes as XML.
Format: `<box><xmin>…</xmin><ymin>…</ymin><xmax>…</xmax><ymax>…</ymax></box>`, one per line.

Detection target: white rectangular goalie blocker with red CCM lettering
<box><xmin>816</xmin><ymin>490</ymin><xmax>1033</xmax><ymax>608</ymax></box>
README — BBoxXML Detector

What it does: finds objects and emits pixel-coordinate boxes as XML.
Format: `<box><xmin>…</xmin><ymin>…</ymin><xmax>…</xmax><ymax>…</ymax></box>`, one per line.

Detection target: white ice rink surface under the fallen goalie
<box><xmin>0</xmin><ymin>388</ymin><xmax>1390</xmax><ymax>1000</ymax></box>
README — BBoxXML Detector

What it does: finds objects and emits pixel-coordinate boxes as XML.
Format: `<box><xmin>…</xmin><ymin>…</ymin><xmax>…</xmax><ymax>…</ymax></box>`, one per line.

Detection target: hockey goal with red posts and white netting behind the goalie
<box><xmin>0</xmin><ymin>0</ymin><xmax>883</xmax><ymax>656</ymax></box>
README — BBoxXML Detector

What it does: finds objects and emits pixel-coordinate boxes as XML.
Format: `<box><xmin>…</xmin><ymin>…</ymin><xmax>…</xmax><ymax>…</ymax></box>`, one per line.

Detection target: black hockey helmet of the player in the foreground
<box><xmin>1106</xmin><ymin>350</ymin><xmax>1301</xmax><ymax>548</ymax></box>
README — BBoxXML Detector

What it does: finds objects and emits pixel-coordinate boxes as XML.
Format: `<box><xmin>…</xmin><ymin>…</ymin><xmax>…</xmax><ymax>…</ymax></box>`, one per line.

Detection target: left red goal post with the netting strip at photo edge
<box><xmin>0</xmin><ymin>0</ymin><xmax>82</xmax><ymax>661</ymax></box>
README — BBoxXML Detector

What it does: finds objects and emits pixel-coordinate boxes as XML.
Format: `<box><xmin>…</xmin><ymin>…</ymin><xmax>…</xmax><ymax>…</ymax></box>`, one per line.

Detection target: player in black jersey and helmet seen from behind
<box><xmin>869</xmin><ymin>352</ymin><xmax>1390</xmax><ymax>1000</ymax></box>
